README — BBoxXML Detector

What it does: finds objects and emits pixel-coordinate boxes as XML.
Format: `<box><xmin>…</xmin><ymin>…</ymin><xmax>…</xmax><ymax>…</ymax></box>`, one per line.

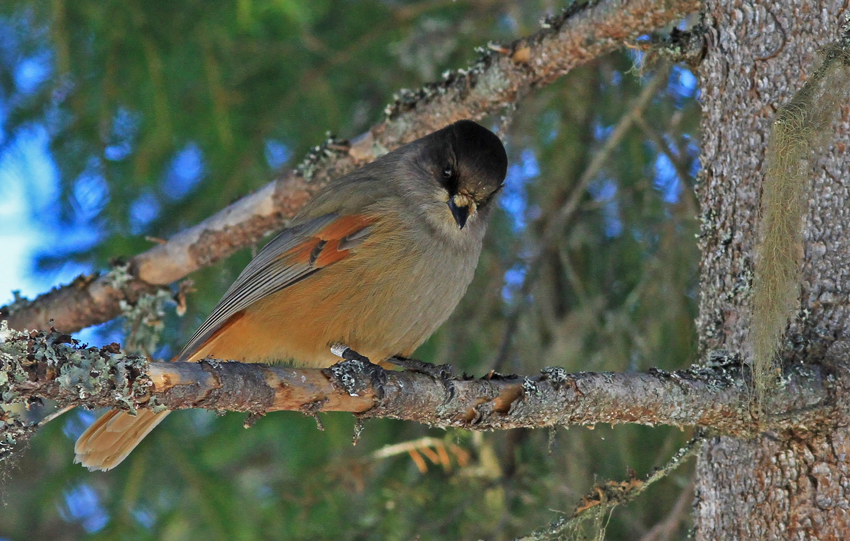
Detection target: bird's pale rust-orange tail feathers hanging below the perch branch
<box><xmin>74</xmin><ymin>410</ymin><xmax>171</xmax><ymax>471</ymax></box>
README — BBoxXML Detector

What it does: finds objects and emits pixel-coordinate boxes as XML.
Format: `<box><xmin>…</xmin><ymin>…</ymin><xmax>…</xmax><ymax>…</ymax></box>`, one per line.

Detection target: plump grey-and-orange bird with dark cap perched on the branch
<box><xmin>75</xmin><ymin>120</ymin><xmax>508</xmax><ymax>470</ymax></box>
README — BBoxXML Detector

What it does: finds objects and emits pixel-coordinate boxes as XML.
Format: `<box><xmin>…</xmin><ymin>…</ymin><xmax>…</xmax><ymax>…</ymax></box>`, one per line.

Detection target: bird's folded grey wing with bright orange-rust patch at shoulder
<box><xmin>175</xmin><ymin>213</ymin><xmax>375</xmax><ymax>361</ymax></box>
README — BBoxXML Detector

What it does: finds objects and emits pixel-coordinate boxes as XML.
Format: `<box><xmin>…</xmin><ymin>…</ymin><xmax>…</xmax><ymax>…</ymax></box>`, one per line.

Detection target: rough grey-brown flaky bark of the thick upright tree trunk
<box><xmin>695</xmin><ymin>0</ymin><xmax>850</xmax><ymax>540</ymax></box>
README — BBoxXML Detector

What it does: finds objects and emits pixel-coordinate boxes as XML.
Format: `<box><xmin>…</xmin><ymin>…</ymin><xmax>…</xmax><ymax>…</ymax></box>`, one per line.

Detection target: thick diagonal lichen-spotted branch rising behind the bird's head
<box><xmin>0</xmin><ymin>0</ymin><xmax>701</xmax><ymax>332</ymax></box>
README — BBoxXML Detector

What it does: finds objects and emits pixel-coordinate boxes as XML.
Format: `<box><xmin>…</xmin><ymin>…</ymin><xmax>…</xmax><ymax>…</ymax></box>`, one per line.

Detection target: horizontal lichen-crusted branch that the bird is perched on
<box><xmin>0</xmin><ymin>320</ymin><xmax>844</xmax><ymax>442</ymax></box>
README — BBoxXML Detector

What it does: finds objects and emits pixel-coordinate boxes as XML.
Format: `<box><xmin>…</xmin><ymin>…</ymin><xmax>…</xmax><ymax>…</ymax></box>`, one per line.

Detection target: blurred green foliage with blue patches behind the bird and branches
<box><xmin>0</xmin><ymin>0</ymin><xmax>699</xmax><ymax>540</ymax></box>
